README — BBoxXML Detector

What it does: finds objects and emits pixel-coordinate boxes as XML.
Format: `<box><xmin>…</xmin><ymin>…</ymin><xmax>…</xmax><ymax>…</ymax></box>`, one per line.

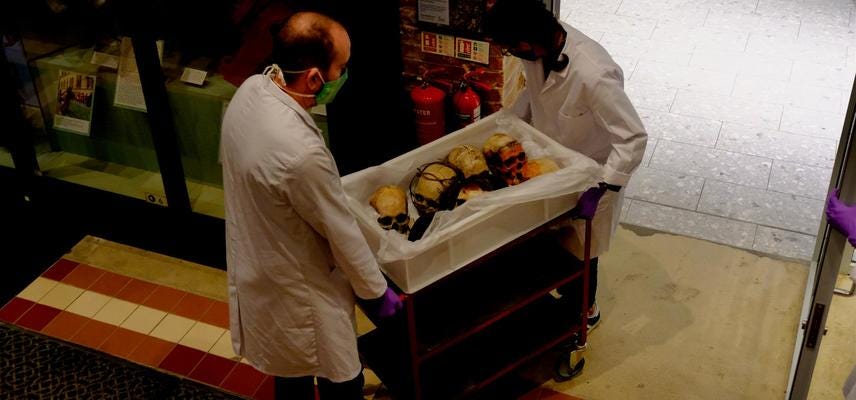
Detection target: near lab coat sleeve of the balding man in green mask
<box><xmin>284</xmin><ymin>148</ymin><xmax>387</xmax><ymax>299</ymax></box>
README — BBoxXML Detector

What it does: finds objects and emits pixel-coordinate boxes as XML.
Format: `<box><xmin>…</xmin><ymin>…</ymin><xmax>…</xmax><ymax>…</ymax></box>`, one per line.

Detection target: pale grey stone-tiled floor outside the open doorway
<box><xmin>562</xmin><ymin>0</ymin><xmax>856</xmax><ymax>260</ymax></box>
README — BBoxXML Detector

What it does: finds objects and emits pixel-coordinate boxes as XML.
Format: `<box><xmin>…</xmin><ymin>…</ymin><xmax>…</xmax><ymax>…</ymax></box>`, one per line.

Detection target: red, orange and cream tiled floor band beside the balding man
<box><xmin>0</xmin><ymin>248</ymin><xmax>576</xmax><ymax>400</ymax></box>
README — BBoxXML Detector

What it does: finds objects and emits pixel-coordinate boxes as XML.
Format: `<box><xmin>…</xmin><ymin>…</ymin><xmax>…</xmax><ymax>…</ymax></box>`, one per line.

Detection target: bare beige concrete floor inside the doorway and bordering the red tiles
<box><xmin>61</xmin><ymin>226</ymin><xmax>856</xmax><ymax>400</ymax></box>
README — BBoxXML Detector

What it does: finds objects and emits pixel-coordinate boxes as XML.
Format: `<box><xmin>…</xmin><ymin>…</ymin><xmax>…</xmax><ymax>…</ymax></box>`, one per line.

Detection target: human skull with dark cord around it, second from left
<box><xmin>410</xmin><ymin>162</ymin><xmax>459</xmax><ymax>215</ymax></box>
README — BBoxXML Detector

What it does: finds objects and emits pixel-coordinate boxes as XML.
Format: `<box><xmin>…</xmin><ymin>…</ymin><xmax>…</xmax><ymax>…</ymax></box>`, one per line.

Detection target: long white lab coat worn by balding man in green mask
<box><xmin>220</xmin><ymin>75</ymin><xmax>386</xmax><ymax>382</ymax></box>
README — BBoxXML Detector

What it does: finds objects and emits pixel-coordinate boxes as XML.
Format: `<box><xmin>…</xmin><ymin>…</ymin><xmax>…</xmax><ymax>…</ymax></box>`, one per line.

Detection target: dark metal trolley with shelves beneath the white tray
<box><xmin>359</xmin><ymin>211</ymin><xmax>591</xmax><ymax>400</ymax></box>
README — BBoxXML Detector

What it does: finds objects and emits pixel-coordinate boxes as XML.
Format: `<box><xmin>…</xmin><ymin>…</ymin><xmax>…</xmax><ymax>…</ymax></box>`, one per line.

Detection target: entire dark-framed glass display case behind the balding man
<box><xmin>5</xmin><ymin>0</ymin><xmax>409</xmax><ymax>218</ymax></box>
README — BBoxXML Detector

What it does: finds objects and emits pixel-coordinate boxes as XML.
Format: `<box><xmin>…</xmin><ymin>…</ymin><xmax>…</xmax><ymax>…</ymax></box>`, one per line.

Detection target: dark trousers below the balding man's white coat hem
<box><xmin>273</xmin><ymin>371</ymin><xmax>365</xmax><ymax>400</ymax></box>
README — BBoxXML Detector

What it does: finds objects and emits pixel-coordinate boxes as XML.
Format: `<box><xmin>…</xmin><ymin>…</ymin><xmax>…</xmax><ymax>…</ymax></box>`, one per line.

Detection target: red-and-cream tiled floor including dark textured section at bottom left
<box><xmin>0</xmin><ymin>259</ymin><xmax>575</xmax><ymax>400</ymax></box>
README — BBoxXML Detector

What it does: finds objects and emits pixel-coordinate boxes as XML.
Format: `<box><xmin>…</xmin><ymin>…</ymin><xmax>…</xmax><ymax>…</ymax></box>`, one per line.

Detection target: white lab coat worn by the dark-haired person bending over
<box><xmin>513</xmin><ymin>23</ymin><xmax>648</xmax><ymax>259</ymax></box>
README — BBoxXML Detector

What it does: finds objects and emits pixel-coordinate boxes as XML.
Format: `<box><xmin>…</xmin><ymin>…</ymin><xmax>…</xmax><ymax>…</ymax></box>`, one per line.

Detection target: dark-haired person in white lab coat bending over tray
<box><xmin>484</xmin><ymin>0</ymin><xmax>648</xmax><ymax>372</ymax></box>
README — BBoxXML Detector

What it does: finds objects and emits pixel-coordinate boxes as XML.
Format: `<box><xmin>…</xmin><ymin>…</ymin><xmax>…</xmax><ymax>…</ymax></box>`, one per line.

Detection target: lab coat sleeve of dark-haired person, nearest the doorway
<box><xmin>592</xmin><ymin>69</ymin><xmax>648</xmax><ymax>186</ymax></box>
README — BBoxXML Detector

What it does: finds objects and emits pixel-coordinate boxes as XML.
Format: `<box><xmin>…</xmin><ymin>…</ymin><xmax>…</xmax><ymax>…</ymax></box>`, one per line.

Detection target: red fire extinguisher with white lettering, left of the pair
<box><xmin>410</xmin><ymin>71</ymin><xmax>446</xmax><ymax>146</ymax></box>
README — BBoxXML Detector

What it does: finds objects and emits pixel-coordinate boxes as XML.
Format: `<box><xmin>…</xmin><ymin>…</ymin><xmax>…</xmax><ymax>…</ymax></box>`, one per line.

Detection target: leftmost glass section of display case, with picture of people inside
<box><xmin>4</xmin><ymin>1</ymin><xmax>166</xmax><ymax>209</ymax></box>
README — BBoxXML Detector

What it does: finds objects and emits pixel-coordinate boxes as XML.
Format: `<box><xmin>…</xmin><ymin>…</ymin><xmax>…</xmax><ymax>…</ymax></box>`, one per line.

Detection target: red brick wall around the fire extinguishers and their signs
<box><xmin>399</xmin><ymin>0</ymin><xmax>503</xmax><ymax>122</ymax></box>
